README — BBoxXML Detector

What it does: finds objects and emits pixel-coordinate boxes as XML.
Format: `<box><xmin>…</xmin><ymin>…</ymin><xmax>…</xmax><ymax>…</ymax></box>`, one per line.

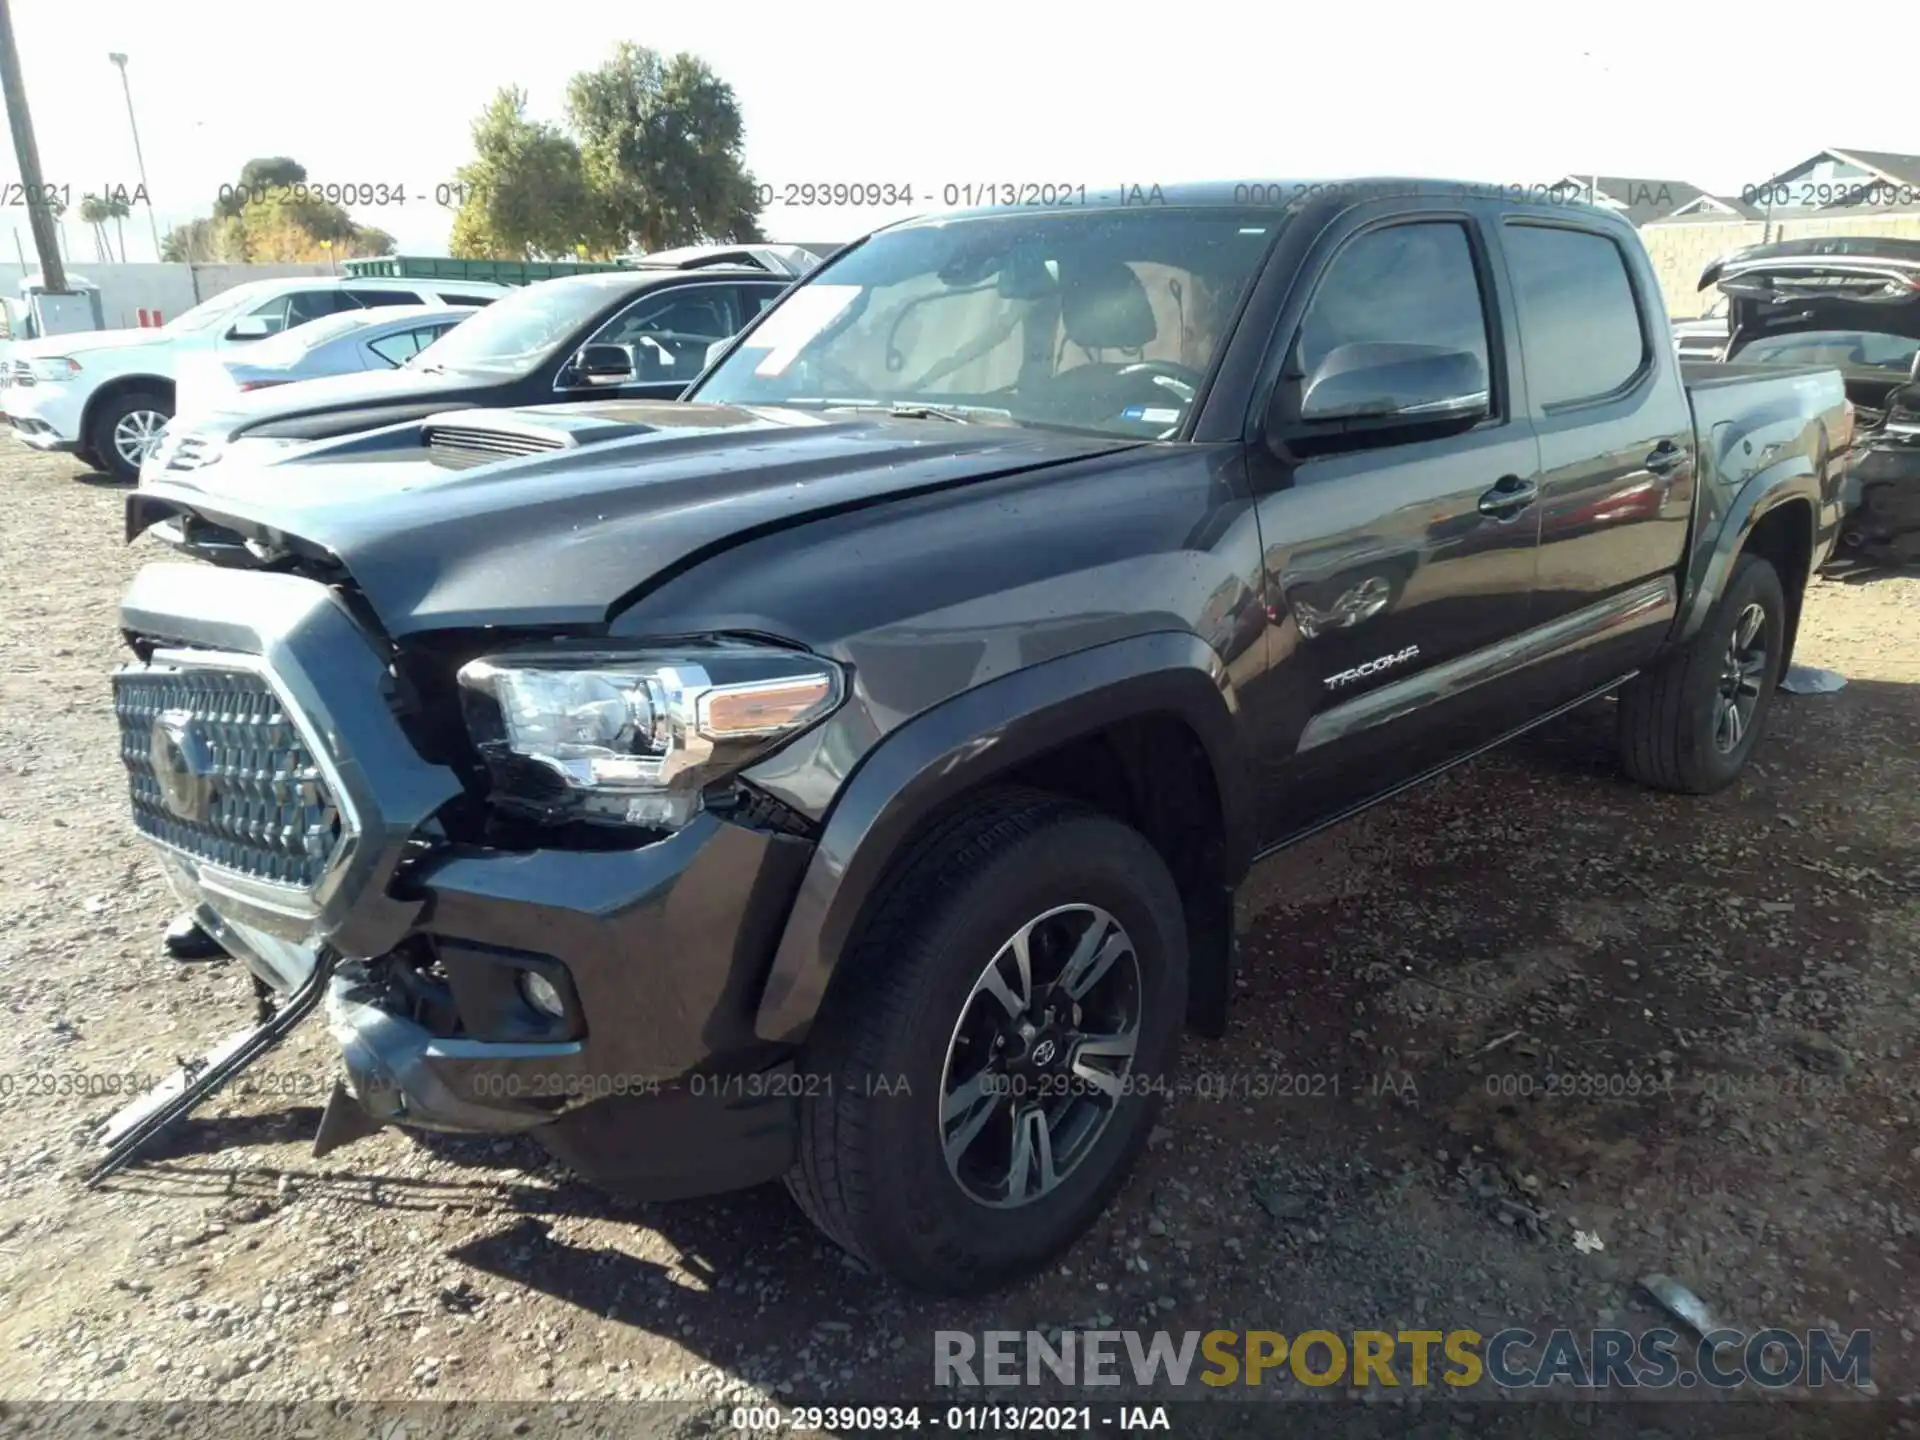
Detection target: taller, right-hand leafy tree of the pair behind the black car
<box><xmin>566</xmin><ymin>42</ymin><xmax>760</xmax><ymax>250</ymax></box>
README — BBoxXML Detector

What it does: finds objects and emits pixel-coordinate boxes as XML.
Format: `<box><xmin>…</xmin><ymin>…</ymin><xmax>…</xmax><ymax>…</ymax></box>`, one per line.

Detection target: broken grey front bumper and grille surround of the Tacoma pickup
<box><xmin>121</xmin><ymin>564</ymin><xmax>812</xmax><ymax>1194</ymax></box>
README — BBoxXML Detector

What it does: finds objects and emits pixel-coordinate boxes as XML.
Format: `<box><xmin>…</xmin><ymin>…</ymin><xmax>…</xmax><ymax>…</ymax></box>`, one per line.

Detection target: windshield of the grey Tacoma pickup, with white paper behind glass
<box><xmin>687</xmin><ymin>207</ymin><xmax>1277</xmax><ymax>438</ymax></box>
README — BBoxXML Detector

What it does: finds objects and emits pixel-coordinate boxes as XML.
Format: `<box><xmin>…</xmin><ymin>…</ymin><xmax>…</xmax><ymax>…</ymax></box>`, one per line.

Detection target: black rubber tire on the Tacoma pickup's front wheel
<box><xmin>787</xmin><ymin>787</ymin><xmax>1187</xmax><ymax>1294</ymax></box>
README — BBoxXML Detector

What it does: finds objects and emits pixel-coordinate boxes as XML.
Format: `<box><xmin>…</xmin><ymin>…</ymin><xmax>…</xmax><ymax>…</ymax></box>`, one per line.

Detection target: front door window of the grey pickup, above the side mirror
<box><xmin>1296</xmin><ymin>221</ymin><xmax>1498</xmax><ymax>391</ymax></box>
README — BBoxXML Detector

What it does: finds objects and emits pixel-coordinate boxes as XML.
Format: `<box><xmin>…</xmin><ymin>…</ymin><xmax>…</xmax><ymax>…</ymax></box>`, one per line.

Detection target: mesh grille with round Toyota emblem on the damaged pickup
<box><xmin>113</xmin><ymin>666</ymin><xmax>344</xmax><ymax>889</ymax></box>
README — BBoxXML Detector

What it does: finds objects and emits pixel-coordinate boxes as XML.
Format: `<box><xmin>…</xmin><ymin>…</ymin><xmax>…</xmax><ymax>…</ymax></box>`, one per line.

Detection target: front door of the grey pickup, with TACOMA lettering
<box><xmin>1248</xmin><ymin>211</ymin><xmax>1540</xmax><ymax>845</ymax></box>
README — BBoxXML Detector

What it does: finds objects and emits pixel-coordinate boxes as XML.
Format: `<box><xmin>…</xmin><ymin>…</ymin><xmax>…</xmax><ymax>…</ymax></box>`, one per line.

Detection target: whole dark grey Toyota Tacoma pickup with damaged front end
<box><xmin>112</xmin><ymin>180</ymin><xmax>1847</xmax><ymax>1292</ymax></box>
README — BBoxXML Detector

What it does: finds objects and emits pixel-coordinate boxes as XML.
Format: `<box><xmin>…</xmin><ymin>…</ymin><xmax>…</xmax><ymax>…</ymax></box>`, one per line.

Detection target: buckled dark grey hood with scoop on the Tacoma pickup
<box><xmin>127</xmin><ymin>401</ymin><xmax>1140</xmax><ymax>637</ymax></box>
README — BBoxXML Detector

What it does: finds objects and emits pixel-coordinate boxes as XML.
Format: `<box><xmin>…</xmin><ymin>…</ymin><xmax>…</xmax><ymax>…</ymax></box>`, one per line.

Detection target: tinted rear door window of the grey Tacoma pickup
<box><xmin>1505</xmin><ymin>223</ymin><xmax>1653</xmax><ymax>407</ymax></box>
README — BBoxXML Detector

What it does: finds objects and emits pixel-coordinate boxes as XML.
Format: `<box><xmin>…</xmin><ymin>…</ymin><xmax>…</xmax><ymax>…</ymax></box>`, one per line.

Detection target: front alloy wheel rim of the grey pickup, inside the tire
<box><xmin>939</xmin><ymin>904</ymin><xmax>1142</xmax><ymax>1210</ymax></box>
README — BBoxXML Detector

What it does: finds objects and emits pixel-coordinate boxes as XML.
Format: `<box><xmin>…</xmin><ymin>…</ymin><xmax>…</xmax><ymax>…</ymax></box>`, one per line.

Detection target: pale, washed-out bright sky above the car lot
<box><xmin>0</xmin><ymin>0</ymin><xmax>1920</xmax><ymax>261</ymax></box>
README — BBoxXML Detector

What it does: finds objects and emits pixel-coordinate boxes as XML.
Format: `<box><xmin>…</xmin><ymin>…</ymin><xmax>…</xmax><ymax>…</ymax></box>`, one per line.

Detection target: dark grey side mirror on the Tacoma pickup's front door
<box><xmin>1267</xmin><ymin>344</ymin><xmax>1492</xmax><ymax>440</ymax></box>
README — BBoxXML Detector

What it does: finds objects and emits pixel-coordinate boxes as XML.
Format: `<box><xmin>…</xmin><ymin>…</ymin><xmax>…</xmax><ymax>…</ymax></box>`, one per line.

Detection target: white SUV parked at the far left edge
<box><xmin>0</xmin><ymin>275</ymin><xmax>511</xmax><ymax>482</ymax></box>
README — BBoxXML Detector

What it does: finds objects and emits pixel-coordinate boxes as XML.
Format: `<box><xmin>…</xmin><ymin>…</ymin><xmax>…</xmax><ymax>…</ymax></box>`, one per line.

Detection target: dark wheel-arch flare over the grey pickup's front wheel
<box><xmin>755</xmin><ymin>632</ymin><xmax>1252</xmax><ymax>1044</ymax></box>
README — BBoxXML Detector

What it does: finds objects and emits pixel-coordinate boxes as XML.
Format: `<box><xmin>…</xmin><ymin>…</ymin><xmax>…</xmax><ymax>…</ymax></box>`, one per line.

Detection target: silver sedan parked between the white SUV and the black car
<box><xmin>175</xmin><ymin>305</ymin><xmax>474</xmax><ymax>417</ymax></box>
